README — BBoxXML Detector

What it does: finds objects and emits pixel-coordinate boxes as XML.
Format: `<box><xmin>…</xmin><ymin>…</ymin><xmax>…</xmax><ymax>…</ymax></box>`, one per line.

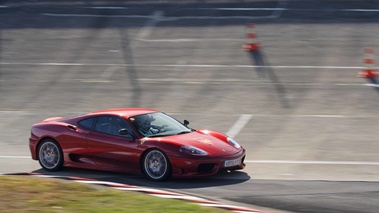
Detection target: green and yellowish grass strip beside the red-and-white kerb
<box><xmin>0</xmin><ymin>176</ymin><xmax>228</xmax><ymax>213</ymax></box>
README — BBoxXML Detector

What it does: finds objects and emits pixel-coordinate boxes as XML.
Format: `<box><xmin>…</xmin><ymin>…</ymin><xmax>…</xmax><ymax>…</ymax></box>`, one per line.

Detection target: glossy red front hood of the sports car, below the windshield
<box><xmin>165</xmin><ymin>131</ymin><xmax>240</xmax><ymax>156</ymax></box>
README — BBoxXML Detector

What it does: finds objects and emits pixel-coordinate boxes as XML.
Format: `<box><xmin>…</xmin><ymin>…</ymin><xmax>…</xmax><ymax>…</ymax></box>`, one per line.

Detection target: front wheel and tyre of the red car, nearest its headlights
<box><xmin>142</xmin><ymin>149</ymin><xmax>171</xmax><ymax>181</ymax></box>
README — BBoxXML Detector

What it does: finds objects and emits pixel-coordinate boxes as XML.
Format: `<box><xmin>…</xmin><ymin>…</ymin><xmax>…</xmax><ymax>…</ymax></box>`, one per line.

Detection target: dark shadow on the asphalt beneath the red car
<box><xmin>32</xmin><ymin>167</ymin><xmax>250</xmax><ymax>189</ymax></box>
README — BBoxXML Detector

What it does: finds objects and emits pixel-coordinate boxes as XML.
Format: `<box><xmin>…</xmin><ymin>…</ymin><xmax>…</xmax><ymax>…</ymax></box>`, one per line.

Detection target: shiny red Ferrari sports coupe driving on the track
<box><xmin>29</xmin><ymin>108</ymin><xmax>245</xmax><ymax>181</ymax></box>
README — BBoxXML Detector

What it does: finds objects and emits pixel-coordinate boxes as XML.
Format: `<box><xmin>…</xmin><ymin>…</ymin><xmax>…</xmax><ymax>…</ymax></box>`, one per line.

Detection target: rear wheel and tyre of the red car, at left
<box><xmin>38</xmin><ymin>139</ymin><xmax>63</xmax><ymax>172</ymax></box>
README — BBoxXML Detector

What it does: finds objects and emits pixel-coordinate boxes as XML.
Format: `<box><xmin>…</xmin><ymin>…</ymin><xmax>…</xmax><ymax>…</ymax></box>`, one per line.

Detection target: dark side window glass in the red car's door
<box><xmin>95</xmin><ymin>116</ymin><xmax>131</xmax><ymax>138</ymax></box>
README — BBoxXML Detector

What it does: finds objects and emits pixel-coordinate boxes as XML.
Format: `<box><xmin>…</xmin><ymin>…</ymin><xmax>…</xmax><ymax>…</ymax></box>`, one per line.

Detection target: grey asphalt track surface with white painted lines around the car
<box><xmin>0</xmin><ymin>0</ymin><xmax>379</xmax><ymax>212</ymax></box>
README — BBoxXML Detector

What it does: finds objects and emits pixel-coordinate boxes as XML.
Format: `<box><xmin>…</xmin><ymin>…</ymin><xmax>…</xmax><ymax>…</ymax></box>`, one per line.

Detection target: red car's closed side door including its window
<box><xmin>87</xmin><ymin>116</ymin><xmax>139</xmax><ymax>171</ymax></box>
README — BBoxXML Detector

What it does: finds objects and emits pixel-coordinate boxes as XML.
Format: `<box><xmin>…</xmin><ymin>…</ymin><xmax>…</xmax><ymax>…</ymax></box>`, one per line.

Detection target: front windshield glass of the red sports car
<box><xmin>129</xmin><ymin>112</ymin><xmax>192</xmax><ymax>137</ymax></box>
